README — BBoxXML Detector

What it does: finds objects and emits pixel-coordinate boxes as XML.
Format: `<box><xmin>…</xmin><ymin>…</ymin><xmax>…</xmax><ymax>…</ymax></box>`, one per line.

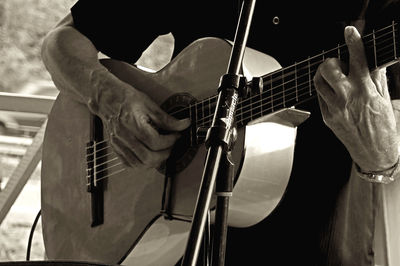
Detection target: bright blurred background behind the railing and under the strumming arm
<box><xmin>0</xmin><ymin>0</ymin><xmax>173</xmax><ymax>262</ymax></box>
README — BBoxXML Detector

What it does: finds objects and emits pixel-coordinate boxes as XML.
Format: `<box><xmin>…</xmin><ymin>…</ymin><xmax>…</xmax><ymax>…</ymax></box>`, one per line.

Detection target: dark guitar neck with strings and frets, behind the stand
<box><xmin>189</xmin><ymin>21</ymin><xmax>400</xmax><ymax>144</ymax></box>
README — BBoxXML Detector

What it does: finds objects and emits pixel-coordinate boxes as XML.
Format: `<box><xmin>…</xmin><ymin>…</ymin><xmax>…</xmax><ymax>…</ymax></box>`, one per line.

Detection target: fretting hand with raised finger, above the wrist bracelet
<box><xmin>314</xmin><ymin>27</ymin><xmax>398</xmax><ymax>172</ymax></box>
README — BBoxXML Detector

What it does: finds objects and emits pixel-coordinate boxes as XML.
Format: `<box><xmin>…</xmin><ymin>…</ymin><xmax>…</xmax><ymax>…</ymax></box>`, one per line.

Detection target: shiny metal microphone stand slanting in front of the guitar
<box><xmin>181</xmin><ymin>0</ymin><xmax>255</xmax><ymax>266</ymax></box>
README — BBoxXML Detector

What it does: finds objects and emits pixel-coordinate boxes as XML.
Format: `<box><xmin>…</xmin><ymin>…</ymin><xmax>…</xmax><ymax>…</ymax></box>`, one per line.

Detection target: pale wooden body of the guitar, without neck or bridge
<box><xmin>41</xmin><ymin>38</ymin><xmax>302</xmax><ymax>265</ymax></box>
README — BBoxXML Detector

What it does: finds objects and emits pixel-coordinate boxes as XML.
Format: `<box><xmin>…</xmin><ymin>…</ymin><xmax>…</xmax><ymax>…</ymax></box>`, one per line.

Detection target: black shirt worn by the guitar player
<box><xmin>72</xmin><ymin>0</ymin><xmax>400</xmax><ymax>265</ymax></box>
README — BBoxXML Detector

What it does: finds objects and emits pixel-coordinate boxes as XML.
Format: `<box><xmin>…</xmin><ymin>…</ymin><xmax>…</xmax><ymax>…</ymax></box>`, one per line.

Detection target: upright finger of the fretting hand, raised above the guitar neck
<box><xmin>344</xmin><ymin>26</ymin><xmax>369</xmax><ymax>78</ymax></box>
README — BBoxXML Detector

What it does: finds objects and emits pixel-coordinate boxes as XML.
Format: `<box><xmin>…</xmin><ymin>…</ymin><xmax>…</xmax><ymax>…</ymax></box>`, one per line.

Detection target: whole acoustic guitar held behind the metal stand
<box><xmin>41</xmin><ymin>22</ymin><xmax>399</xmax><ymax>265</ymax></box>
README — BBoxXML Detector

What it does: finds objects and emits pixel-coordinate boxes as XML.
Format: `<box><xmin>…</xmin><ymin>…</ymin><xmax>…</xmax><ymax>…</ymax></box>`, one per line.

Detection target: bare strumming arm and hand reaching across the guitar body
<box><xmin>42</xmin><ymin>15</ymin><xmax>190</xmax><ymax>167</ymax></box>
